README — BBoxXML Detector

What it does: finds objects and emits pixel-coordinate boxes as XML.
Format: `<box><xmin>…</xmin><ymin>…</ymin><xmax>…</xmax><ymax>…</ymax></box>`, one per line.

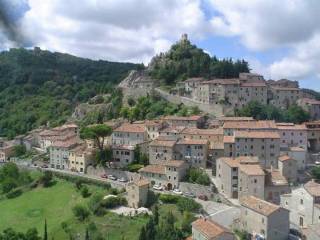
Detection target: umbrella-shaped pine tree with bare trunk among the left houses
<box><xmin>81</xmin><ymin>124</ymin><xmax>112</xmax><ymax>152</ymax></box>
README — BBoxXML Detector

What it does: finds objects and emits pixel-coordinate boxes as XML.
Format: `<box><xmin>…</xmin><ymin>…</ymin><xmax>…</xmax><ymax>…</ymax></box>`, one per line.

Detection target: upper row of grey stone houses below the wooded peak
<box><xmin>176</xmin><ymin>73</ymin><xmax>320</xmax><ymax>120</ymax></box>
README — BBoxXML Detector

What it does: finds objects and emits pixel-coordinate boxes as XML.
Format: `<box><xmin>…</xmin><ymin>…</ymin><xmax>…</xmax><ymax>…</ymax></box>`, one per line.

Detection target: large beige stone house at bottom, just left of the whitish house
<box><xmin>240</xmin><ymin>196</ymin><xmax>289</xmax><ymax>240</ymax></box>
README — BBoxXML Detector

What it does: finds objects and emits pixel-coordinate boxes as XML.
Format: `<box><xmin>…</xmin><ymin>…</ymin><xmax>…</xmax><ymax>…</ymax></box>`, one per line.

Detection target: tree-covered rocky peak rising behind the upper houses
<box><xmin>149</xmin><ymin>35</ymin><xmax>250</xmax><ymax>85</ymax></box>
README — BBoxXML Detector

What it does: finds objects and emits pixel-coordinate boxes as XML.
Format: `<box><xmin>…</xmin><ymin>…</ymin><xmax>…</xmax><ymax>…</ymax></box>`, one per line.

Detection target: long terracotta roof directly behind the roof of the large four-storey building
<box><xmin>223</xmin><ymin>120</ymin><xmax>277</xmax><ymax>129</ymax></box>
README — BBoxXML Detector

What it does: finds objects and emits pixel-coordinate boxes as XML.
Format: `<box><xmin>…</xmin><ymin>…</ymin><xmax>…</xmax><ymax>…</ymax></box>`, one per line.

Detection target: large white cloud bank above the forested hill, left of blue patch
<box><xmin>17</xmin><ymin>0</ymin><xmax>209</xmax><ymax>63</ymax></box>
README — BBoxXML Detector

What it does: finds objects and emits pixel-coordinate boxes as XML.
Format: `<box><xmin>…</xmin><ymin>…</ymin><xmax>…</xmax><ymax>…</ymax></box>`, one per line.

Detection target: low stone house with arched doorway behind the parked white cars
<box><xmin>139</xmin><ymin>160</ymin><xmax>188</xmax><ymax>190</ymax></box>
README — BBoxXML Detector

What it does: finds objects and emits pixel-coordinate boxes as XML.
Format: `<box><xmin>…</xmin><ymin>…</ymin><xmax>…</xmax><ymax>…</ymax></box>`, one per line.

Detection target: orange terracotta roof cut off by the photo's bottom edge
<box><xmin>192</xmin><ymin>218</ymin><xmax>232</xmax><ymax>240</ymax></box>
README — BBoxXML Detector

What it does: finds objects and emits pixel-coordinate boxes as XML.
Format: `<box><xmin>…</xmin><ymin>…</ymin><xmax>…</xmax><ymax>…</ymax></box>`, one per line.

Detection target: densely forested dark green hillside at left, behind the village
<box><xmin>0</xmin><ymin>48</ymin><xmax>139</xmax><ymax>137</ymax></box>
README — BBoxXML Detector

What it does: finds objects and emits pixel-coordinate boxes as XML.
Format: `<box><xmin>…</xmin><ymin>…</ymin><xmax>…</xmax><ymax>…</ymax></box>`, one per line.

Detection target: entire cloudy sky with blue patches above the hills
<box><xmin>0</xmin><ymin>0</ymin><xmax>320</xmax><ymax>90</ymax></box>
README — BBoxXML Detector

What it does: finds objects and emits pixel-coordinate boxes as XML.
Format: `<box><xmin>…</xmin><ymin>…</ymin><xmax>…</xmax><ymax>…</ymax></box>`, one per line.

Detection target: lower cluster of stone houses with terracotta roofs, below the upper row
<box><xmin>0</xmin><ymin>111</ymin><xmax>320</xmax><ymax>240</ymax></box>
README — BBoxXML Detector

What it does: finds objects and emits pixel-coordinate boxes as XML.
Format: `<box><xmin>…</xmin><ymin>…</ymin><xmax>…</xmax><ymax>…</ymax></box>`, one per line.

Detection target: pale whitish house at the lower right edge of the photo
<box><xmin>280</xmin><ymin>180</ymin><xmax>320</xmax><ymax>228</ymax></box>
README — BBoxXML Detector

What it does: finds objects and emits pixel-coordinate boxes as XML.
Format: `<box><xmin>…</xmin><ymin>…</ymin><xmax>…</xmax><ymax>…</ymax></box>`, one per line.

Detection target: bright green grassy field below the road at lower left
<box><xmin>0</xmin><ymin>177</ymin><xmax>147</xmax><ymax>240</ymax></box>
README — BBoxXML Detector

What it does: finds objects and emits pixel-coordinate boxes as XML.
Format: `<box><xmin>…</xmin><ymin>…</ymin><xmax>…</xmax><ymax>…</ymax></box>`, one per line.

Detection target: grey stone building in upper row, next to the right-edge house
<box><xmin>269</xmin><ymin>86</ymin><xmax>301</xmax><ymax>109</ymax></box>
